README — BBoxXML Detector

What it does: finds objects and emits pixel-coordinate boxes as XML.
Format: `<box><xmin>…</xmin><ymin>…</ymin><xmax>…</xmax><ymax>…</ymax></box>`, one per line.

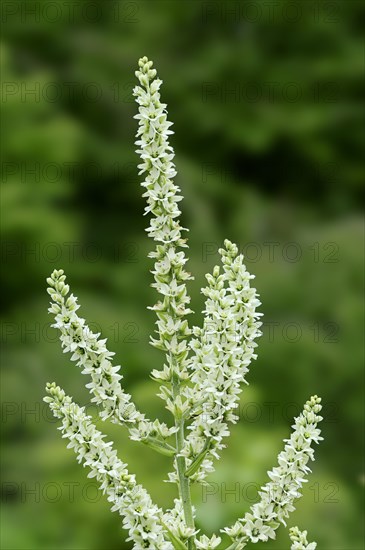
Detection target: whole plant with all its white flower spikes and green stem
<box><xmin>45</xmin><ymin>57</ymin><xmax>322</xmax><ymax>550</ymax></box>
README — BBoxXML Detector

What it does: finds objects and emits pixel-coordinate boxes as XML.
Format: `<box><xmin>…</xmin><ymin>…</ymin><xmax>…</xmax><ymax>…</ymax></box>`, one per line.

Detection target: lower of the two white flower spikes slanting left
<box><xmin>44</xmin><ymin>383</ymin><xmax>173</xmax><ymax>550</ymax></box>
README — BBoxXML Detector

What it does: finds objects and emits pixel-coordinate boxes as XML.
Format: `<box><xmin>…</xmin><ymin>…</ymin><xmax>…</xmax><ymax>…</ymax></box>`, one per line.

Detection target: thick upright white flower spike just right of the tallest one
<box><xmin>183</xmin><ymin>240</ymin><xmax>262</xmax><ymax>482</ymax></box>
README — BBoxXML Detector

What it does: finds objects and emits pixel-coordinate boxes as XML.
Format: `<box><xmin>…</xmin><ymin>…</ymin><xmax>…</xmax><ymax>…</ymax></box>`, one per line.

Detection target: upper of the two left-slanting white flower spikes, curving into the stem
<box><xmin>47</xmin><ymin>269</ymin><xmax>175</xmax><ymax>456</ymax></box>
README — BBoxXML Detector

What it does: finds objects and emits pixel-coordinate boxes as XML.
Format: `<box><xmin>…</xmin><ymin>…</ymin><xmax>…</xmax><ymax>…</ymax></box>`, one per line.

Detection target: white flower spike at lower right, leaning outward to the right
<box><xmin>223</xmin><ymin>395</ymin><xmax>323</xmax><ymax>548</ymax></box>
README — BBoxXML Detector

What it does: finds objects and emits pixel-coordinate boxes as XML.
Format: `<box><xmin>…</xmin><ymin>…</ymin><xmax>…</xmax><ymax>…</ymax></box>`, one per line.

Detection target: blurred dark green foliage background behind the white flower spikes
<box><xmin>1</xmin><ymin>0</ymin><xmax>365</xmax><ymax>550</ymax></box>
